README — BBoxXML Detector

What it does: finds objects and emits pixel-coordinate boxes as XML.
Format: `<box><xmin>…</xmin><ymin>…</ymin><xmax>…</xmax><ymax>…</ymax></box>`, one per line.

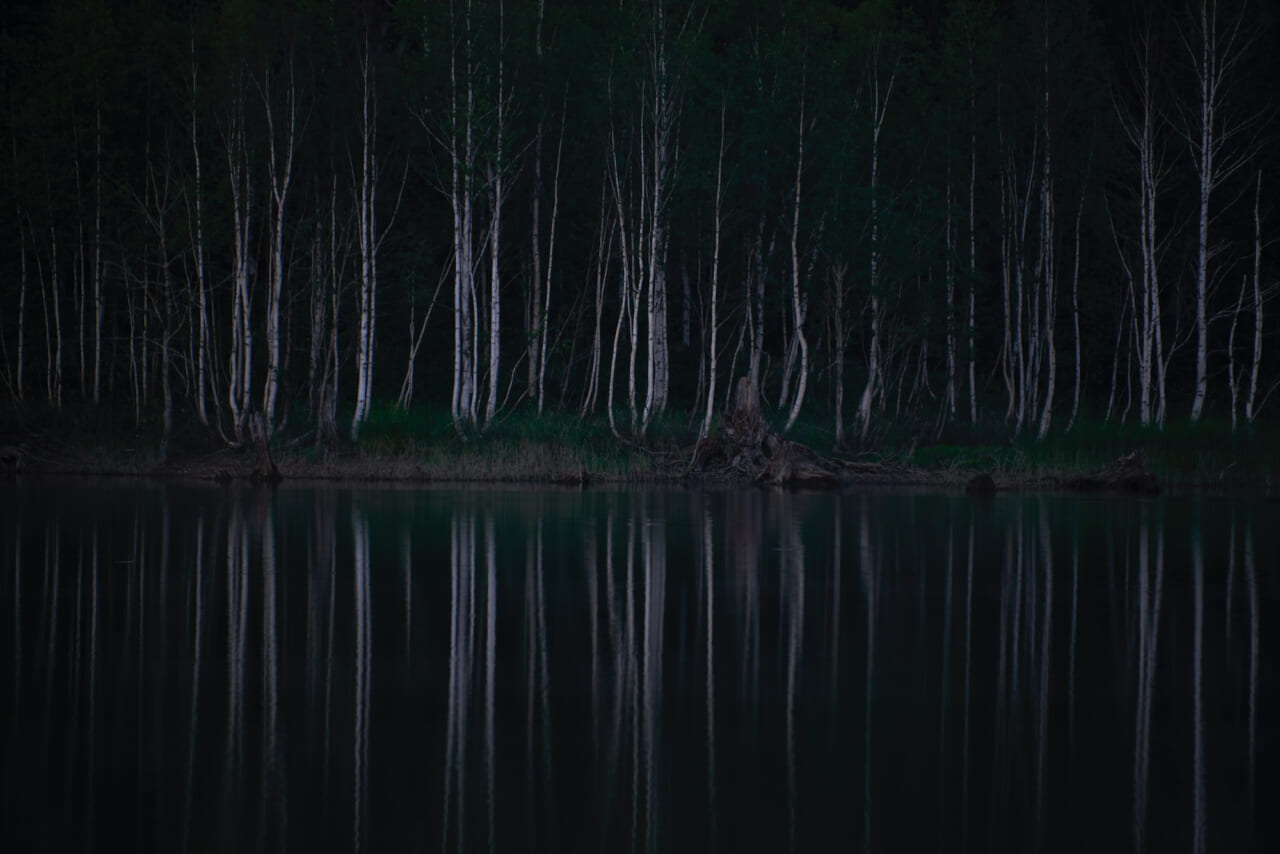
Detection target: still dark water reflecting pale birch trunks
<box><xmin>0</xmin><ymin>483</ymin><xmax>1280</xmax><ymax>853</ymax></box>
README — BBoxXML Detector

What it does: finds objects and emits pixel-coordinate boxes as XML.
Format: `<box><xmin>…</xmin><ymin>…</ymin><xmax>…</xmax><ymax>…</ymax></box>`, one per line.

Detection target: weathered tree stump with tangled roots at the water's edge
<box><xmin>690</xmin><ymin>376</ymin><xmax>841</xmax><ymax>485</ymax></box>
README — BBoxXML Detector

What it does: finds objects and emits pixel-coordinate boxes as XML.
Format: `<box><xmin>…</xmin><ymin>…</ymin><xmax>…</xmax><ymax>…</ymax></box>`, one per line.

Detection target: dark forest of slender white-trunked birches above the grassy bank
<box><xmin>0</xmin><ymin>0</ymin><xmax>1280</xmax><ymax>463</ymax></box>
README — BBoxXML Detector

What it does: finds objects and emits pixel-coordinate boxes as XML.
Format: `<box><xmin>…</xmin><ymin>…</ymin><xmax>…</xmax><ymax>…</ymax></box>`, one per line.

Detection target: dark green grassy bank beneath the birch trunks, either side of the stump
<box><xmin>0</xmin><ymin>399</ymin><xmax>1280</xmax><ymax>492</ymax></box>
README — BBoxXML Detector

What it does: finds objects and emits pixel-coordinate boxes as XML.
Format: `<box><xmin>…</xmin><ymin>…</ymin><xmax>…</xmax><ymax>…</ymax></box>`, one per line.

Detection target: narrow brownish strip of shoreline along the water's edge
<box><xmin>0</xmin><ymin>444</ymin><xmax>1276</xmax><ymax>498</ymax></box>
